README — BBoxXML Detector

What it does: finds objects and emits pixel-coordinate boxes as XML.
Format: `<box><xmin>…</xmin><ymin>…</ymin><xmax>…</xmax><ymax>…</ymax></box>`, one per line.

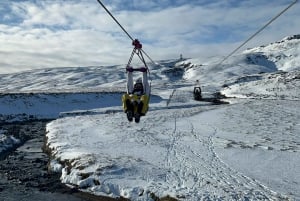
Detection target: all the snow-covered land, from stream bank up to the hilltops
<box><xmin>0</xmin><ymin>36</ymin><xmax>300</xmax><ymax>200</ymax></box>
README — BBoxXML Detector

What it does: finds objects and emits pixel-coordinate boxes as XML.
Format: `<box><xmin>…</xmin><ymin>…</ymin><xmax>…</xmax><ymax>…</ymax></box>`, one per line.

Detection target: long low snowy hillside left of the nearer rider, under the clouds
<box><xmin>0</xmin><ymin>66</ymin><xmax>126</xmax><ymax>94</ymax></box>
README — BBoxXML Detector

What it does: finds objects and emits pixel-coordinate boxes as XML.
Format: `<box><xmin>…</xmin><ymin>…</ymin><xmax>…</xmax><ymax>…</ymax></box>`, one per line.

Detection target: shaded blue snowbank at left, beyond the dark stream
<box><xmin>0</xmin><ymin>92</ymin><xmax>122</xmax><ymax>122</ymax></box>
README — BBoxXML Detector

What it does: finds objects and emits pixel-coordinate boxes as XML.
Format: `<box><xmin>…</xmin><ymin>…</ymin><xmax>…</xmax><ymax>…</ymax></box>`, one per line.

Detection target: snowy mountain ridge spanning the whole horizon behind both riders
<box><xmin>0</xmin><ymin>35</ymin><xmax>300</xmax><ymax>93</ymax></box>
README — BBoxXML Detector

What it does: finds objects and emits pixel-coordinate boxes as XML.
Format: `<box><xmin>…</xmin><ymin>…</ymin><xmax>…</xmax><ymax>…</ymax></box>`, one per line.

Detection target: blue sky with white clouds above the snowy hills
<box><xmin>0</xmin><ymin>0</ymin><xmax>300</xmax><ymax>73</ymax></box>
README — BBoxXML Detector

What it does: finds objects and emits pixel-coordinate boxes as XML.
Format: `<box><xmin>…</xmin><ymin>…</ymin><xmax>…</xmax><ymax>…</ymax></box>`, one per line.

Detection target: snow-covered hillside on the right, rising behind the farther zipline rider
<box><xmin>176</xmin><ymin>35</ymin><xmax>300</xmax><ymax>100</ymax></box>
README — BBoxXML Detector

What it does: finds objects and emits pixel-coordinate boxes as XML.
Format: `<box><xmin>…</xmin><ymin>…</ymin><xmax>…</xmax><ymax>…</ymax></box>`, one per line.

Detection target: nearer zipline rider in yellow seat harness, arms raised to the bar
<box><xmin>122</xmin><ymin>66</ymin><xmax>150</xmax><ymax>123</ymax></box>
